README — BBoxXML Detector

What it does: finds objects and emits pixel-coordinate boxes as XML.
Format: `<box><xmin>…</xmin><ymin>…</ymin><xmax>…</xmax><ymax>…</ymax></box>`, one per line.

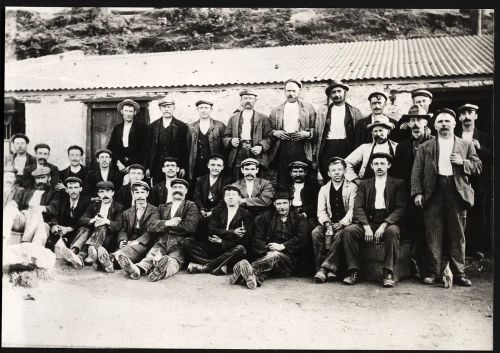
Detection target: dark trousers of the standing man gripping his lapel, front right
<box><xmin>424</xmin><ymin>175</ymin><xmax>467</xmax><ymax>277</ymax></box>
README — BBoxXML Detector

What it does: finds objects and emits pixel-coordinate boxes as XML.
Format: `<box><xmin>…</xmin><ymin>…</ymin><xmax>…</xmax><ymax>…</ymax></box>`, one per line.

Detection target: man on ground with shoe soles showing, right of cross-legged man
<box><xmin>229</xmin><ymin>191</ymin><xmax>307</xmax><ymax>289</ymax></box>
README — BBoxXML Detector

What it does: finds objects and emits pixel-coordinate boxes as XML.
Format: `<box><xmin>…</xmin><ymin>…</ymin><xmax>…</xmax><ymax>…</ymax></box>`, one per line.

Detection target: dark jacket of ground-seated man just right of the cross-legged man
<box><xmin>252</xmin><ymin>209</ymin><xmax>307</xmax><ymax>258</ymax></box>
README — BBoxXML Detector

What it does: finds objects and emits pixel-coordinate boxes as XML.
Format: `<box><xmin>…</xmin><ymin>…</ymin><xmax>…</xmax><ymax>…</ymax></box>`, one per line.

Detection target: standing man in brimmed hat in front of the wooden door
<box><xmin>108</xmin><ymin>99</ymin><xmax>147</xmax><ymax>172</ymax></box>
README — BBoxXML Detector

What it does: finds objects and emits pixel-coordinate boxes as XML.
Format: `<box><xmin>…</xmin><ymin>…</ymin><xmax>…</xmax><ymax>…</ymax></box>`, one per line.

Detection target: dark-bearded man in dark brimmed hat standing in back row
<box><xmin>314</xmin><ymin>80</ymin><xmax>363</xmax><ymax>180</ymax></box>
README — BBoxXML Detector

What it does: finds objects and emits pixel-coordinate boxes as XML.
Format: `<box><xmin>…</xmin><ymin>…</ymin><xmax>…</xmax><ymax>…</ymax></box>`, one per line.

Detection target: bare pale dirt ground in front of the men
<box><xmin>2</xmin><ymin>260</ymin><xmax>493</xmax><ymax>350</ymax></box>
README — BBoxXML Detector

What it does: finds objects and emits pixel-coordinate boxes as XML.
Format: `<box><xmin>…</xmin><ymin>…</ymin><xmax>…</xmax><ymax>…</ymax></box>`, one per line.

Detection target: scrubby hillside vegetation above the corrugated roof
<box><xmin>6</xmin><ymin>8</ymin><xmax>493</xmax><ymax>60</ymax></box>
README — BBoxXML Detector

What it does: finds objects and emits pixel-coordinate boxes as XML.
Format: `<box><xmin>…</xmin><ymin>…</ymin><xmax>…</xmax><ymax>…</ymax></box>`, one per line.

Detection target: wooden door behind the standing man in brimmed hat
<box><xmin>86</xmin><ymin>100</ymin><xmax>149</xmax><ymax>168</ymax></box>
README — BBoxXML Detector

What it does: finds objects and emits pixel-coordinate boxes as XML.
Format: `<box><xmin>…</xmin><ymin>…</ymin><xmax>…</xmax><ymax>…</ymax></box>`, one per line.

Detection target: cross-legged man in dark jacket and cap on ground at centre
<box><xmin>184</xmin><ymin>185</ymin><xmax>253</xmax><ymax>275</ymax></box>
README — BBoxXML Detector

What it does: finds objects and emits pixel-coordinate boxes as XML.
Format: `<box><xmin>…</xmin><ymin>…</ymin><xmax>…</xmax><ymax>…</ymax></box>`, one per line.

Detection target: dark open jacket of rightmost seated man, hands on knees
<box><xmin>352</xmin><ymin>175</ymin><xmax>408</xmax><ymax>225</ymax></box>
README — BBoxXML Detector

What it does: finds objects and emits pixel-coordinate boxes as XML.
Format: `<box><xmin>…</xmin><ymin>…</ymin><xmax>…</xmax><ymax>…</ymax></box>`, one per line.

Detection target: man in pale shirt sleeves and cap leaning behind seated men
<box><xmin>345</xmin><ymin>116</ymin><xmax>398</xmax><ymax>183</ymax></box>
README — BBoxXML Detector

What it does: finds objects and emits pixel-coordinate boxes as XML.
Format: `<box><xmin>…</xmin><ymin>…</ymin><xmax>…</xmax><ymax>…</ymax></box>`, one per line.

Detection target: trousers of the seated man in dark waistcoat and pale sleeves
<box><xmin>311</xmin><ymin>225</ymin><xmax>343</xmax><ymax>273</ymax></box>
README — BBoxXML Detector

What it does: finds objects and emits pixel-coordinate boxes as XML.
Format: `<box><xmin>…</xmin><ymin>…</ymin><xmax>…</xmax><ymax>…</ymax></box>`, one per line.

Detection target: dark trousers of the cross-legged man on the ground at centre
<box><xmin>184</xmin><ymin>238</ymin><xmax>247</xmax><ymax>275</ymax></box>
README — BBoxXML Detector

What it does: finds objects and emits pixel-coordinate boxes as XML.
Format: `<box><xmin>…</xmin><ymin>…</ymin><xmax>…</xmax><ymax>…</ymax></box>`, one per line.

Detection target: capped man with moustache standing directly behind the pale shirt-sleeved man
<box><xmin>354</xmin><ymin>92</ymin><xmax>397</xmax><ymax>148</ymax></box>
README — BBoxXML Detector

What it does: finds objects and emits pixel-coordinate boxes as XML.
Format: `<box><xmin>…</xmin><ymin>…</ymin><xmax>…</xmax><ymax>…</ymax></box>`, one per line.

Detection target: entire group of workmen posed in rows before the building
<box><xmin>3</xmin><ymin>79</ymin><xmax>492</xmax><ymax>289</ymax></box>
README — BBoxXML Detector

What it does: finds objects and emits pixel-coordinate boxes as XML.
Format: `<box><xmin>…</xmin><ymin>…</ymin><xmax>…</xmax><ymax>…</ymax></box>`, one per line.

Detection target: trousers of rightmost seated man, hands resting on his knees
<box><xmin>342</xmin><ymin>224</ymin><xmax>399</xmax><ymax>272</ymax></box>
